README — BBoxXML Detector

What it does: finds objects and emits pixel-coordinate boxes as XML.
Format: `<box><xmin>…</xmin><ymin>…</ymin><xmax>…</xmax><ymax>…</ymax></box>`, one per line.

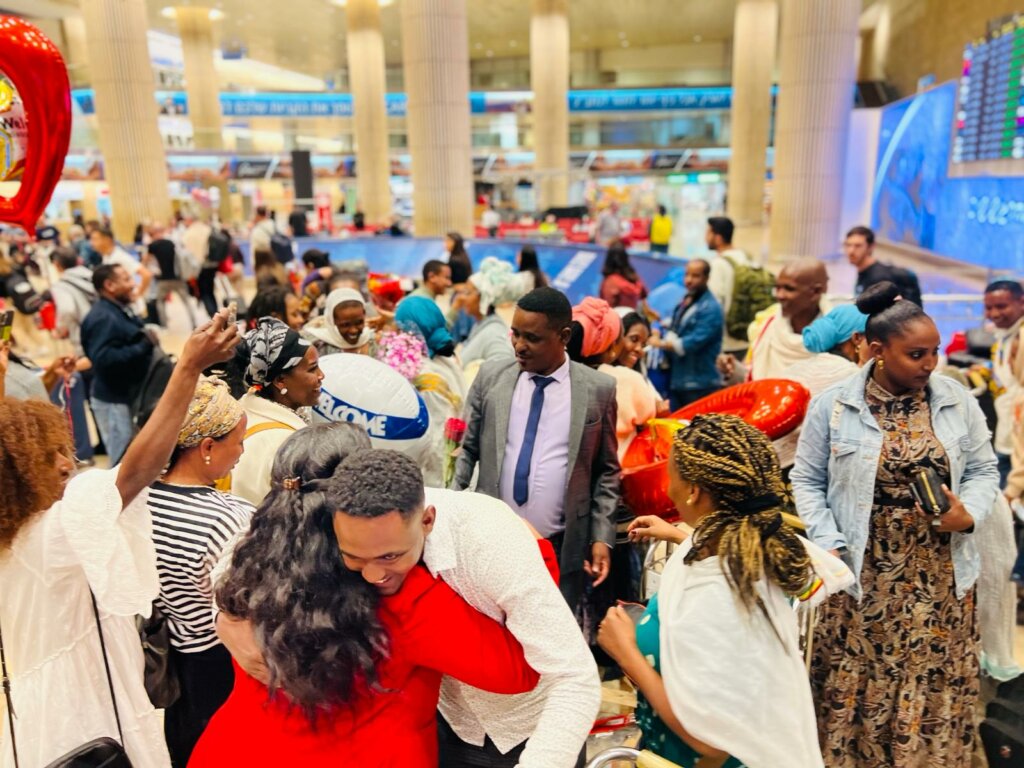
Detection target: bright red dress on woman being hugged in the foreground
<box><xmin>188</xmin><ymin>565</ymin><xmax>539</xmax><ymax>768</ymax></box>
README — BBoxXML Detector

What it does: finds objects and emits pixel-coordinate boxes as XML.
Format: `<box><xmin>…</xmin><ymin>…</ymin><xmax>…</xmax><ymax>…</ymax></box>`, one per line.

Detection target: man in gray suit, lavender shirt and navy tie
<box><xmin>453</xmin><ymin>288</ymin><xmax>620</xmax><ymax>609</ymax></box>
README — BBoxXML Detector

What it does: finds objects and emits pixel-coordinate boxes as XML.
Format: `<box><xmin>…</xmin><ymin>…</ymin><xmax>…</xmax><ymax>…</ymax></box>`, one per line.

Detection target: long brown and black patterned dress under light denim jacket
<box><xmin>811</xmin><ymin>379</ymin><xmax>980</xmax><ymax>768</ymax></box>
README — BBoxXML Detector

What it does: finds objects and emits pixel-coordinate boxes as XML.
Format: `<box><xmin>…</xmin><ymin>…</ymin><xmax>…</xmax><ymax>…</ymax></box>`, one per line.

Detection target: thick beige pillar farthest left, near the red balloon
<box><xmin>81</xmin><ymin>0</ymin><xmax>171</xmax><ymax>242</ymax></box>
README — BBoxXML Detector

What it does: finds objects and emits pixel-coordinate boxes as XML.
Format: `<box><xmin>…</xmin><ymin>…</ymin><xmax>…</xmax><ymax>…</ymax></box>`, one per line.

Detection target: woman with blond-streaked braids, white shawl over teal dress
<box><xmin>598</xmin><ymin>414</ymin><xmax>852</xmax><ymax>768</ymax></box>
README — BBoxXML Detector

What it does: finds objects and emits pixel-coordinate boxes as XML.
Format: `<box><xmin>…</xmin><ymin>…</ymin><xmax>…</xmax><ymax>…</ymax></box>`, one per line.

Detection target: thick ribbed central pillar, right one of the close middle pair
<box><xmin>401</xmin><ymin>0</ymin><xmax>473</xmax><ymax>238</ymax></box>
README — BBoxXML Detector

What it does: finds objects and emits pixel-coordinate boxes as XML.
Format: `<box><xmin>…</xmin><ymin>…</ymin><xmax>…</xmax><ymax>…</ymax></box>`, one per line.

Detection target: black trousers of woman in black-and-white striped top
<box><xmin>164</xmin><ymin>645</ymin><xmax>234</xmax><ymax>768</ymax></box>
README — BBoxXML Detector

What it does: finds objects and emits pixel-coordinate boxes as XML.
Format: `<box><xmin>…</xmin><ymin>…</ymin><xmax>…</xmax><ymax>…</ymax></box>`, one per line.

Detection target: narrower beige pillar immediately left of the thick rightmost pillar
<box><xmin>728</xmin><ymin>0</ymin><xmax>778</xmax><ymax>255</ymax></box>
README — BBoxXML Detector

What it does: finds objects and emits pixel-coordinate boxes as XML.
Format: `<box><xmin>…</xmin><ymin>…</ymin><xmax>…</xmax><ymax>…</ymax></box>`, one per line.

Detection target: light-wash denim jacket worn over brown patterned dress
<box><xmin>791</xmin><ymin>365</ymin><xmax>999</xmax><ymax>600</ymax></box>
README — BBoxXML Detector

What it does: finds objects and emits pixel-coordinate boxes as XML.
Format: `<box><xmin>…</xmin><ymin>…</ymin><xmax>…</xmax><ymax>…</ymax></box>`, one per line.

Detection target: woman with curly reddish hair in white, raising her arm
<box><xmin>0</xmin><ymin>310</ymin><xmax>239</xmax><ymax>768</ymax></box>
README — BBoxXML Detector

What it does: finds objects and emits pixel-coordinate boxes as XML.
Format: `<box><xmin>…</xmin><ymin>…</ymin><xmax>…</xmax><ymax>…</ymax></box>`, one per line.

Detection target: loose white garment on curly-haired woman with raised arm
<box><xmin>0</xmin><ymin>468</ymin><xmax>170</xmax><ymax>768</ymax></box>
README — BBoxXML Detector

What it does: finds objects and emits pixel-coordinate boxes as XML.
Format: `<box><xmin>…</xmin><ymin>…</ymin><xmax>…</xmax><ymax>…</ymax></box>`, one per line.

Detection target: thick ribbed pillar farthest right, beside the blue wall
<box><xmin>771</xmin><ymin>0</ymin><xmax>861</xmax><ymax>261</ymax></box>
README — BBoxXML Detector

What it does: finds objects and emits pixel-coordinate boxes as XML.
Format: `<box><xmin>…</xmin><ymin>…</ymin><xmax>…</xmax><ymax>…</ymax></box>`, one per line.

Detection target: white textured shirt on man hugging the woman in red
<box><xmin>423</xmin><ymin>489</ymin><xmax>601</xmax><ymax>768</ymax></box>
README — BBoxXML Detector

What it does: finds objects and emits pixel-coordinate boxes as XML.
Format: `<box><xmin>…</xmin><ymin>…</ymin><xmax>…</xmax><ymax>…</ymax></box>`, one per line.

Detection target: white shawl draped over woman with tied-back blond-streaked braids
<box><xmin>658</xmin><ymin>539</ymin><xmax>852</xmax><ymax>768</ymax></box>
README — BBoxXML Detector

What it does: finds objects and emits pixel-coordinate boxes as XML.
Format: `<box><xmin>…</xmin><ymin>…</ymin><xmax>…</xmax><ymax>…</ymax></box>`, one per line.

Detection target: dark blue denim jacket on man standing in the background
<box><xmin>669</xmin><ymin>291</ymin><xmax>724</xmax><ymax>392</ymax></box>
